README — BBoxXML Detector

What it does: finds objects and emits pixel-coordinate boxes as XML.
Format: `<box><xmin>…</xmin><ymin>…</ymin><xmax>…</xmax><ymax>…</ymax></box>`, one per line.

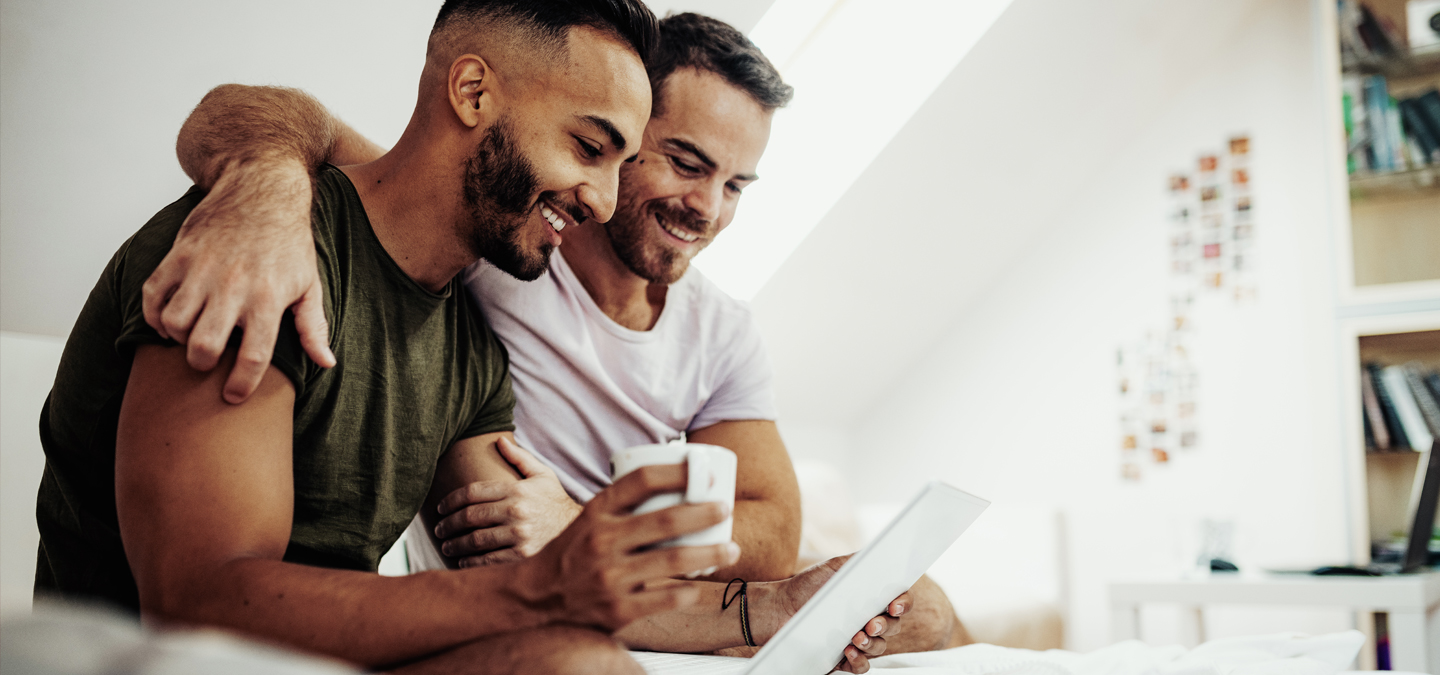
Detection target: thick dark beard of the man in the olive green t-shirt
<box><xmin>455</xmin><ymin>118</ymin><xmax>554</xmax><ymax>281</ymax></box>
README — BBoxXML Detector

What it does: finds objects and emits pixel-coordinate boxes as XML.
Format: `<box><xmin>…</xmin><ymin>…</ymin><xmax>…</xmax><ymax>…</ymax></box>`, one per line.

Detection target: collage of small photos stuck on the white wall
<box><xmin>1116</xmin><ymin>135</ymin><xmax>1256</xmax><ymax>481</ymax></box>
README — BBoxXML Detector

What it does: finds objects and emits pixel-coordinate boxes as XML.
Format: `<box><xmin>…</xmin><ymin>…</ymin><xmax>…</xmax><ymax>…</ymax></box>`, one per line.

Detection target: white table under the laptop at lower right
<box><xmin>1110</xmin><ymin>571</ymin><xmax>1440</xmax><ymax>675</ymax></box>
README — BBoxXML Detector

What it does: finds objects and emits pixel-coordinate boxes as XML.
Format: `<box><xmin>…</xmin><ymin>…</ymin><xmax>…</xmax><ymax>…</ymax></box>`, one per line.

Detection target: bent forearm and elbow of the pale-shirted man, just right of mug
<box><xmin>706</xmin><ymin>498</ymin><xmax>801</xmax><ymax>583</ymax></box>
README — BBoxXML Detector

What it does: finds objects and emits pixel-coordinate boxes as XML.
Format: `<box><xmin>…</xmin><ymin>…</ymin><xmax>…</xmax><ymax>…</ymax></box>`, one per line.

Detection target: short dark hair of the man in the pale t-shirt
<box><xmin>647</xmin><ymin>12</ymin><xmax>795</xmax><ymax>117</ymax></box>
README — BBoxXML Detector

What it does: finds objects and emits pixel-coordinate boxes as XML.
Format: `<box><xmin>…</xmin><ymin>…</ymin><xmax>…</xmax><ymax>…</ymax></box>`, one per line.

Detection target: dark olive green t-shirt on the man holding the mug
<box><xmin>35</xmin><ymin>166</ymin><xmax>514</xmax><ymax>609</ymax></box>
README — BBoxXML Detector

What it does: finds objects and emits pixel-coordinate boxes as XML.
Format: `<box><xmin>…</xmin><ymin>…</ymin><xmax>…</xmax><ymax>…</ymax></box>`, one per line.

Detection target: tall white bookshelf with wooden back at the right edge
<box><xmin>1315</xmin><ymin>0</ymin><xmax>1440</xmax><ymax>564</ymax></box>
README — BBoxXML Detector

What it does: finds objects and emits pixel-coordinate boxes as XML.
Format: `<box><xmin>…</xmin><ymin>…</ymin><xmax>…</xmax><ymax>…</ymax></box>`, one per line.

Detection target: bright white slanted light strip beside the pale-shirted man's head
<box><xmin>696</xmin><ymin>0</ymin><xmax>1011</xmax><ymax>299</ymax></box>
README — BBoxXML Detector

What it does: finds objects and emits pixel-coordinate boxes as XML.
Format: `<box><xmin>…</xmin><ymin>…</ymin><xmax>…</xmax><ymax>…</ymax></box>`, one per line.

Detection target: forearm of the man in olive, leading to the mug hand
<box><xmin>157</xmin><ymin>558</ymin><xmax>549</xmax><ymax>668</ymax></box>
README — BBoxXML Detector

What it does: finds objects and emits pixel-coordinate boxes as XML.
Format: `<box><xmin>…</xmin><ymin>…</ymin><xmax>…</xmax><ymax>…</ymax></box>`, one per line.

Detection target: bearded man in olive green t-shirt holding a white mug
<box><xmin>36</xmin><ymin>0</ymin><xmax>739</xmax><ymax>674</ymax></box>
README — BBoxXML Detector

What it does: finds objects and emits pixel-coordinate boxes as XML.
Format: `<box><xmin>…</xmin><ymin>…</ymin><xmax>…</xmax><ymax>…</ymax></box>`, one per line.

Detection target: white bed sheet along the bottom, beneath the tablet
<box><xmin>634</xmin><ymin>630</ymin><xmax>1365</xmax><ymax>675</ymax></box>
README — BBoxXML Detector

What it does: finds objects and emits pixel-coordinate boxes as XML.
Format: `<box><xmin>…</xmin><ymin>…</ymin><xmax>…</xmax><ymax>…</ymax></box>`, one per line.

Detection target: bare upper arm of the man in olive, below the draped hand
<box><xmin>115</xmin><ymin>345</ymin><xmax>295</xmax><ymax>613</ymax></box>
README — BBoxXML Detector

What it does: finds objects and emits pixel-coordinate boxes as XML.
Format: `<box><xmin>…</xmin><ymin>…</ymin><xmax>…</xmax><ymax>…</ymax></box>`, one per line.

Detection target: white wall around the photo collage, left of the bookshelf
<box><xmin>812</xmin><ymin>0</ymin><xmax>1349</xmax><ymax>649</ymax></box>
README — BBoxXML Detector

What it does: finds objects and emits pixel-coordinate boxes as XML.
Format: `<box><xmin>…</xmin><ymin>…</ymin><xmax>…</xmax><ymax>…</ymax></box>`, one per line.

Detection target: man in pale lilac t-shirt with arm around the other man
<box><xmin>145</xmin><ymin>7</ymin><xmax>966</xmax><ymax>658</ymax></box>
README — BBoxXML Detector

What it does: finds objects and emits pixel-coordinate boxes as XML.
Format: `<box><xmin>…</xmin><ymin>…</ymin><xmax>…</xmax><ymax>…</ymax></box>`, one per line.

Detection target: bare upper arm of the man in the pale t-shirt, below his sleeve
<box><xmin>687</xmin><ymin>420</ymin><xmax>799</xmax><ymax>503</ymax></box>
